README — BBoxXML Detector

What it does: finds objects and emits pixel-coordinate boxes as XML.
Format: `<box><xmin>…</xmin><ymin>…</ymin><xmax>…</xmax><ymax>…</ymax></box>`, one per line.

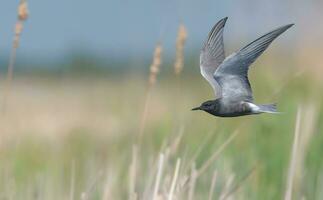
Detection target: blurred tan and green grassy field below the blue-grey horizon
<box><xmin>0</xmin><ymin>56</ymin><xmax>323</xmax><ymax>199</ymax></box>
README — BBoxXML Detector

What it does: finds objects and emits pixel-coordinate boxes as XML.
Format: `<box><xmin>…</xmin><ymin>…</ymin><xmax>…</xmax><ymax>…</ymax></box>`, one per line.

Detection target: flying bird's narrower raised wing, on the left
<box><xmin>200</xmin><ymin>17</ymin><xmax>228</xmax><ymax>96</ymax></box>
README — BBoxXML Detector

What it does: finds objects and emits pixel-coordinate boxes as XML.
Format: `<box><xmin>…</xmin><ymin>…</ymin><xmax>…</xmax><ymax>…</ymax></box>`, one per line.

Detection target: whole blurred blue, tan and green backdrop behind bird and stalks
<box><xmin>0</xmin><ymin>0</ymin><xmax>323</xmax><ymax>199</ymax></box>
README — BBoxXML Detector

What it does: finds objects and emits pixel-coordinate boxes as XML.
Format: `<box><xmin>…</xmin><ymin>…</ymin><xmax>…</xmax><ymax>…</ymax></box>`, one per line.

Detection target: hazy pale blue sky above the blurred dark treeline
<box><xmin>0</xmin><ymin>0</ymin><xmax>322</xmax><ymax>59</ymax></box>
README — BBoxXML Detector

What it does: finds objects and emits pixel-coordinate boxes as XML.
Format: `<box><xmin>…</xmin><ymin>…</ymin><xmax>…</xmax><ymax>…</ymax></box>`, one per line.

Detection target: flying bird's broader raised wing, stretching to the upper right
<box><xmin>214</xmin><ymin>24</ymin><xmax>293</xmax><ymax>102</ymax></box>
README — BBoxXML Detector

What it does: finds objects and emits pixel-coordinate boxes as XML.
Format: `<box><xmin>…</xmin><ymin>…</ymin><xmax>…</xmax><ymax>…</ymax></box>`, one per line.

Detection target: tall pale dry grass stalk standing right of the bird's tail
<box><xmin>285</xmin><ymin>108</ymin><xmax>302</xmax><ymax>200</ymax></box>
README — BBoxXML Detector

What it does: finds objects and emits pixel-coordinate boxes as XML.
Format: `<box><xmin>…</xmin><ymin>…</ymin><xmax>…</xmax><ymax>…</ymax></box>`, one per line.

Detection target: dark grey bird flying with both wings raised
<box><xmin>192</xmin><ymin>17</ymin><xmax>293</xmax><ymax>117</ymax></box>
